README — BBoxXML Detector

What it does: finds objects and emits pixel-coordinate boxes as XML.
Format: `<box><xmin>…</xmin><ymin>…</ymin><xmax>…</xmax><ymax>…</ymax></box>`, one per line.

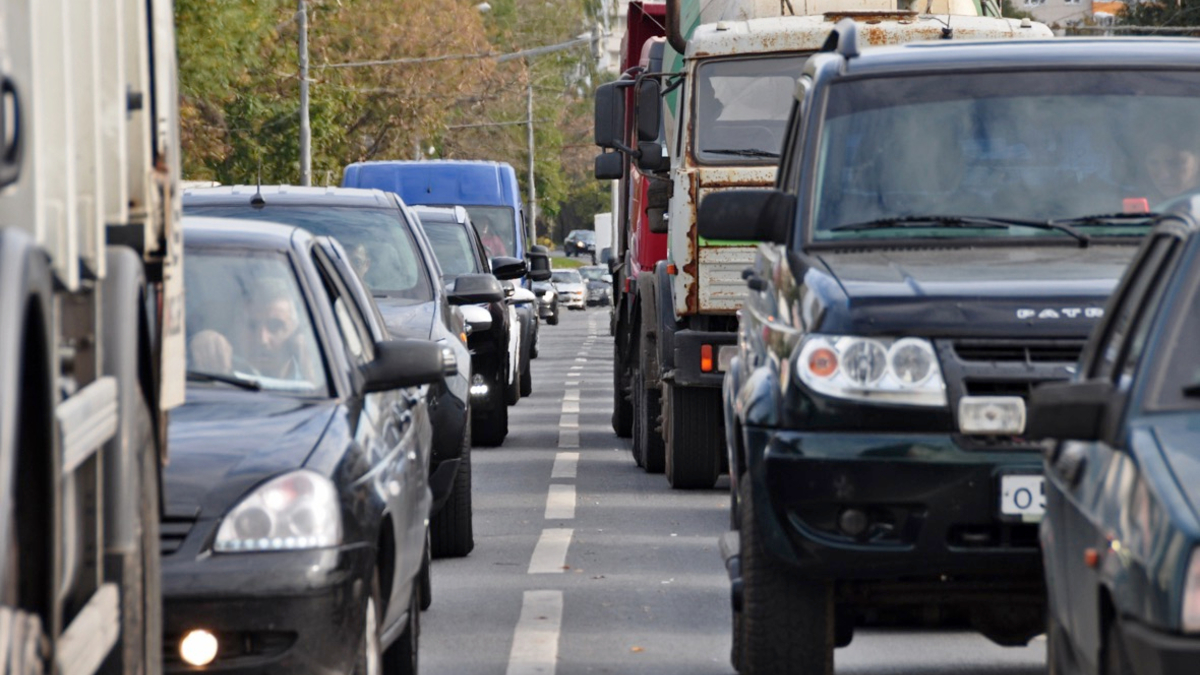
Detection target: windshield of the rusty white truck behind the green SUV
<box><xmin>695</xmin><ymin>54</ymin><xmax>808</xmax><ymax>165</ymax></box>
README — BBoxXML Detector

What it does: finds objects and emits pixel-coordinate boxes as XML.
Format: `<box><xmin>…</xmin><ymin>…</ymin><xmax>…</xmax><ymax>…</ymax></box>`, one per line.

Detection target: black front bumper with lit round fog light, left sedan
<box><xmin>162</xmin><ymin>544</ymin><xmax>373</xmax><ymax>675</ymax></box>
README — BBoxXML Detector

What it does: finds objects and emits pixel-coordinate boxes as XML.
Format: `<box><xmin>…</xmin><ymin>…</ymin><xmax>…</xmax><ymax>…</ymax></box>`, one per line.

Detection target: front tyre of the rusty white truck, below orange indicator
<box><xmin>662</xmin><ymin>384</ymin><xmax>725</xmax><ymax>490</ymax></box>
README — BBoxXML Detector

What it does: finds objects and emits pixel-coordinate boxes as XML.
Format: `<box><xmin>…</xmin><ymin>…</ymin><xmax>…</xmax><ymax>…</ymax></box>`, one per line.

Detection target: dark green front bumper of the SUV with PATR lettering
<box><xmin>745</xmin><ymin>428</ymin><xmax>1043</xmax><ymax>593</ymax></box>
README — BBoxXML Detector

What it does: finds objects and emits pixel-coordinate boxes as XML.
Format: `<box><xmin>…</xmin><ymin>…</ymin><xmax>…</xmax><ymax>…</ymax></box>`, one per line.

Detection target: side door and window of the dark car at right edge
<box><xmin>1045</xmin><ymin>234</ymin><xmax>1181</xmax><ymax>664</ymax></box>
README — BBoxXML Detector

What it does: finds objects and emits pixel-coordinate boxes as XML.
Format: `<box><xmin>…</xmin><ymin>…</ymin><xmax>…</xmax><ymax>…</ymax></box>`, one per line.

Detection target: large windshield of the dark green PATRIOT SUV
<box><xmin>809</xmin><ymin>71</ymin><xmax>1200</xmax><ymax>241</ymax></box>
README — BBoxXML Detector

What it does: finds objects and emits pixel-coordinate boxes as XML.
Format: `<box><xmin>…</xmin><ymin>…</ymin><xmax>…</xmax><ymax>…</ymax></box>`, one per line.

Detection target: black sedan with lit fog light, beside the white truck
<box><xmin>161</xmin><ymin>219</ymin><xmax>452</xmax><ymax>674</ymax></box>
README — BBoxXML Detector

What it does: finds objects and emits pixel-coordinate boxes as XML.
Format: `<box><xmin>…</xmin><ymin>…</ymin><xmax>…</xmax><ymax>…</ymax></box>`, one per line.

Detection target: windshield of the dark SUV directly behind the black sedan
<box><xmin>185</xmin><ymin>204</ymin><xmax>433</xmax><ymax>301</ymax></box>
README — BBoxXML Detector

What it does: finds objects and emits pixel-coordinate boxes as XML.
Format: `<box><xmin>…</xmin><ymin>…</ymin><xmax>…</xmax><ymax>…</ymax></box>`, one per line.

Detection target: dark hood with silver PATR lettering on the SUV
<box><xmin>809</xmin><ymin>244</ymin><xmax>1138</xmax><ymax>339</ymax></box>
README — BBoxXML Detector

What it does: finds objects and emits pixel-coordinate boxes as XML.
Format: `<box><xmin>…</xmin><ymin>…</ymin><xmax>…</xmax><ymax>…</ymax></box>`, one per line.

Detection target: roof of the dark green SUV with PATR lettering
<box><xmin>822</xmin><ymin>37</ymin><xmax>1200</xmax><ymax>74</ymax></box>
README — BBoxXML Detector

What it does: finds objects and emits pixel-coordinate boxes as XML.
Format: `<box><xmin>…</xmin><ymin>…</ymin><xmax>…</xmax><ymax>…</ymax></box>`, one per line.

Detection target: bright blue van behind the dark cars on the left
<box><xmin>342</xmin><ymin>160</ymin><xmax>529</xmax><ymax>258</ymax></box>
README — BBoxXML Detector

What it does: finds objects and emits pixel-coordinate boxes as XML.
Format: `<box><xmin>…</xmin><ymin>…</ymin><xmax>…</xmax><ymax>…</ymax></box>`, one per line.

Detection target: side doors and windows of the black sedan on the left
<box><xmin>313</xmin><ymin>246</ymin><xmax>432</xmax><ymax>626</ymax></box>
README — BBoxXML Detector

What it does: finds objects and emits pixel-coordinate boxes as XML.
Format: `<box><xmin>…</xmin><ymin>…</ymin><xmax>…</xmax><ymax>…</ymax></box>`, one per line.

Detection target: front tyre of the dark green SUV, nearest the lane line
<box><xmin>733</xmin><ymin>480</ymin><xmax>834</xmax><ymax>675</ymax></box>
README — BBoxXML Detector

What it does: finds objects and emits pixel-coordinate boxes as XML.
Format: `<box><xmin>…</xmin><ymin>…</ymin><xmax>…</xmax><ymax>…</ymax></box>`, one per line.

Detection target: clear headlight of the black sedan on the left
<box><xmin>212</xmin><ymin>470</ymin><xmax>342</xmax><ymax>552</ymax></box>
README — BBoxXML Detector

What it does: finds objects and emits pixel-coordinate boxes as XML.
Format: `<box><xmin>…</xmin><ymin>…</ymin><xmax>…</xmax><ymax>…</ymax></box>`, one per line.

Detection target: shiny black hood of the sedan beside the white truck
<box><xmin>163</xmin><ymin>387</ymin><xmax>338</xmax><ymax>518</ymax></box>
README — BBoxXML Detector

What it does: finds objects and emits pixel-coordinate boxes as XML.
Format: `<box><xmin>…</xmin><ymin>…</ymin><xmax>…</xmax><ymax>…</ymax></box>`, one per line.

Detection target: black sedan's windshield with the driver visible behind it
<box><xmin>184</xmin><ymin>247</ymin><xmax>329</xmax><ymax>396</ymax></box>
